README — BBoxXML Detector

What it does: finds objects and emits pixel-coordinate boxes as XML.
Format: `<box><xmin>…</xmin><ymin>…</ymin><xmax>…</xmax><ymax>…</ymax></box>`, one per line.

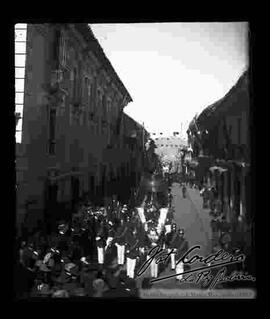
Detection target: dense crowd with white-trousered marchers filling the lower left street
<box><xmin>15</xmin><ymin>191</ymin><xmax>188</xmax><ymax>298</ymax></box>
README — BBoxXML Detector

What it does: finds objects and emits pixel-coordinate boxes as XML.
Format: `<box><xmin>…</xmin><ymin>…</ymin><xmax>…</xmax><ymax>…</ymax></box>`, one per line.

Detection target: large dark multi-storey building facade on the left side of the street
<box><xmin>15</xmin><ymin>24</ymin><xmax>132</xmax><ymax>232</ymax></box>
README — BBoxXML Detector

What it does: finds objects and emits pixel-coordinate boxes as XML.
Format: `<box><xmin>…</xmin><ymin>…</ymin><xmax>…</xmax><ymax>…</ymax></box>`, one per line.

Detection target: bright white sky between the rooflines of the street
<box><xmin>91</xmin><ymin>22</ymin><xmax>248</xmax><ymax>138</ymax></box>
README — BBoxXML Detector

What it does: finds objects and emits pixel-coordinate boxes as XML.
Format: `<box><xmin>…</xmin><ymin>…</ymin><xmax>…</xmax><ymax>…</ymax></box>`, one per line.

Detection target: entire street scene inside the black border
<box><xmin>14</xmin><ymin>20</ymin><xmax>253</xmax><ymax>299</ymax></box>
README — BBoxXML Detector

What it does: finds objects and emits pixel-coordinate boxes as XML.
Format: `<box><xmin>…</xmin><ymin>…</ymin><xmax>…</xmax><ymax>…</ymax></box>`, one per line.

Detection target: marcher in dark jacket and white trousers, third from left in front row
<box><xmin>126</xmin><ymin>227</ymin><xmax>141</xmax><ymax>279</ymax></box>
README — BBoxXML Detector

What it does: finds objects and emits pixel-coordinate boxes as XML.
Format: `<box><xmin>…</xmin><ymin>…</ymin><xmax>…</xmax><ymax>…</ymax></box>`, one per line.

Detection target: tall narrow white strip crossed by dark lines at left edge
<box><xmin>14</xmin><ymin>23</ymin><xmax>27</xmax><ymax>143</ymax></box>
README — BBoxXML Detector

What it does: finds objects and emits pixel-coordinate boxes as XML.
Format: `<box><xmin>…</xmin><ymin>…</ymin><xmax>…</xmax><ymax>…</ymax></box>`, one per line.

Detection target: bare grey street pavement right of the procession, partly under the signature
<box><xmin>137</xmin><ymin>183</ymin><xmax>211</xmax><ymax>289</ymax></box>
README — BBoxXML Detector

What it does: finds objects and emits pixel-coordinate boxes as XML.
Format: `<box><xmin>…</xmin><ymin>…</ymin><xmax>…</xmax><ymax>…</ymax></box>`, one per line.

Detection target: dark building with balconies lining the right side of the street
<box><xmin>187</xmin><ymin>71</ymin><xmax>251</xmax><ymax>234</ymax></box>
